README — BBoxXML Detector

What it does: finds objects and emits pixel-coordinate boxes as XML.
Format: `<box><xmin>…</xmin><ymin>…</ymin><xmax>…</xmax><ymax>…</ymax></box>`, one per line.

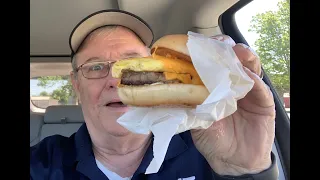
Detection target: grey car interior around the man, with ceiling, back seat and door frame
<box><xmin>30</xmin><ymin>0</ymin><xmax>290</xmax><ymax>180</ymax></box>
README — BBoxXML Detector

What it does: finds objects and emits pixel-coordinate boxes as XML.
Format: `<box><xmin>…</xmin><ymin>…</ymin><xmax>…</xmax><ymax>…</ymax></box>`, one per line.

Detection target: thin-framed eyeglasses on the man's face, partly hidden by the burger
<box><xmin>76</xmin><ymin>61</ymin><xmax>114</xmax><ymax>79</ymax></box>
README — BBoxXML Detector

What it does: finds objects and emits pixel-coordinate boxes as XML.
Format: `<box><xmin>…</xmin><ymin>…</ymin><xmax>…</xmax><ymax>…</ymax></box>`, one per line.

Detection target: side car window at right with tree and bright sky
<box><xmin>235</xmin><ymin>0</ymin><xmax>290</xmax><ymax>119</ymax></box>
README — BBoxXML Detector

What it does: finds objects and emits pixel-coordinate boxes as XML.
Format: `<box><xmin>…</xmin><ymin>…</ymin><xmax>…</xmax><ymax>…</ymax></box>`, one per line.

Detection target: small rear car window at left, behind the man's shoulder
<box><xmin>30</xmin><ymin>76</ymin><xmax>78</xmax><ymax>110</ymax></box>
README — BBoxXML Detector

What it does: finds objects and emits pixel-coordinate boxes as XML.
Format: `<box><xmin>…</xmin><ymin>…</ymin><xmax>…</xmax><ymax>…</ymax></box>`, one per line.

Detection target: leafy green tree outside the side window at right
<box><xmin>249</xmin><ymin>0</ymin><xmax>290</xmax><ymax>97</ymax></box>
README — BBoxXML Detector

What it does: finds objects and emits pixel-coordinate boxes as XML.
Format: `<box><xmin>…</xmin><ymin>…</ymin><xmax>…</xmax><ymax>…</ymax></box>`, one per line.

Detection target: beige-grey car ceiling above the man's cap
<box><xmin>30</xmin><ymin>0</ymin><xmax>238</xmax><ymax>77</ymax></box>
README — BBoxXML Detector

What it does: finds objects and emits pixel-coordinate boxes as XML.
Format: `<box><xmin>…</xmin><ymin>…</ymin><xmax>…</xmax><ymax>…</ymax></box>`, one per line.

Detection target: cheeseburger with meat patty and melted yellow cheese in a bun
<box><xmin>112</xmin><ymin>34</ymin><xmax>209</xmax><ymax>107</ymax></box>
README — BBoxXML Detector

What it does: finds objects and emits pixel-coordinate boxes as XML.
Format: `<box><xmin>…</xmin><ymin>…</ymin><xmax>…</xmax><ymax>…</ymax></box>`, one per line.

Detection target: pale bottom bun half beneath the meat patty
<box><xmin>118</xmin><ymin>84</ymin><xmax>209</xmax><ymax>107</ymax></box>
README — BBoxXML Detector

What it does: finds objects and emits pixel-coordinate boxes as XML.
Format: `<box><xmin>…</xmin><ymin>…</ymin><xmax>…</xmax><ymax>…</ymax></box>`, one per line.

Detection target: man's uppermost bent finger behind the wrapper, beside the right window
<box><xmin>233</xmin><ymin>43</ymin><xmax>262</xmax><ymax>76</ymax></box>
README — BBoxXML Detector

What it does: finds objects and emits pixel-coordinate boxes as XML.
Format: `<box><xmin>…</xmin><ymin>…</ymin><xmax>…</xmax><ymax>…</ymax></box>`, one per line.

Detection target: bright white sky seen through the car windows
<box><xmin>30</xmin><ymin>0</ymin><xmax>280</xmax><ymax>96</ymax></box>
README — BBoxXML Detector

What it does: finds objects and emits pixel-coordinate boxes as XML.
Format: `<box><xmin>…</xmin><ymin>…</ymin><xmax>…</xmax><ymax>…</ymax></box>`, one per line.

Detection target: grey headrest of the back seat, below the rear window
<box><xmin>44</xmin><ymin>105</ymin><xmax>84</xmax><ymax>124</ymax></box>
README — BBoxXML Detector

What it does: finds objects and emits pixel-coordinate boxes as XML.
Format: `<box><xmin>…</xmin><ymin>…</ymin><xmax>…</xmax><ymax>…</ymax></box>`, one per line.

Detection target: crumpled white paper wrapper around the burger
<box><xmin>117</xmin><ymin>31</ymin><xmax>254</xmax><ymax>174</ymax></box>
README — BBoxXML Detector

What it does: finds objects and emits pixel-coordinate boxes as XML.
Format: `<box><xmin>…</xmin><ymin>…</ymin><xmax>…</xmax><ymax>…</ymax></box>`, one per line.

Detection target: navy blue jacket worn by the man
<box><xmin>30</xmin><ymin>123</ymin><xmax>277</xmax><ymax>180</ymax></box>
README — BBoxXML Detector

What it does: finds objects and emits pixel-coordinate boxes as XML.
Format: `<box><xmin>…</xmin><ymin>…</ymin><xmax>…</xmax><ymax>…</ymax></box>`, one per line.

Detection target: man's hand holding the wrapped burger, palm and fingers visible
<box><xmin>191</xmin><ymin>36</ymin><xmax>275</xmax><ymax>176</ymax></box>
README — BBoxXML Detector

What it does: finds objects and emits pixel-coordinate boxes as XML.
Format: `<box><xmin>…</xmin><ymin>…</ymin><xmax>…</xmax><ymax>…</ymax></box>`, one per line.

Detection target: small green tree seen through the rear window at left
<box><xmin>37</xmin><ymin>76</ymin><xmax>76</xmax><ymax>104</ymax></box>
